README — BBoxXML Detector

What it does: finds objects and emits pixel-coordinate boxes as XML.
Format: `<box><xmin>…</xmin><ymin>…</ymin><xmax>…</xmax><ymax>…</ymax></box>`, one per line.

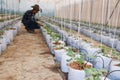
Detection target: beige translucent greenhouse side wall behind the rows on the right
<box><xmin>56</xmin><ymin>0</ymin><xmax>120</xmax><ymax>27</ymax></box>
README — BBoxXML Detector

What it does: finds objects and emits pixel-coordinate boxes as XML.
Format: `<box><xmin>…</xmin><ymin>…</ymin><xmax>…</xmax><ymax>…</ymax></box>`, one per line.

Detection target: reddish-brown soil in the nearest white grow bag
<box><xmin>69</xmin><ymin>61</ymin><xmax>92</xmax><ymax>70</ymax></box>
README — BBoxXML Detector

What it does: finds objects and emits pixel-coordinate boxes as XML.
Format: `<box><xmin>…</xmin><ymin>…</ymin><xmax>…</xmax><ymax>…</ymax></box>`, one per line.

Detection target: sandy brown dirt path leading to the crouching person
<box><xmin>0</xmin><ymin>27</ymin><xmax>62</xmax><ymax>80</ymax></box>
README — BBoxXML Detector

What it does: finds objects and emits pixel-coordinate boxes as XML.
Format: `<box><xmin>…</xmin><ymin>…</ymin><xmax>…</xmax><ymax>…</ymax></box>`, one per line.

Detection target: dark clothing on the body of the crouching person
<box><xmin>22</xmin><ymin>10</ymin><xmax>39</xmax><ymax>29</ymax></box>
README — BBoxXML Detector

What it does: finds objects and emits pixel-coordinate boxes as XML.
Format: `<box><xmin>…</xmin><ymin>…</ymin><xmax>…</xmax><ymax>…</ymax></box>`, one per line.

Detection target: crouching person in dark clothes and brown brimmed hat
<box><xmin>22</xmin><ymin>4</ymin><xmax>42</xmax><ymax>33</ymax></box>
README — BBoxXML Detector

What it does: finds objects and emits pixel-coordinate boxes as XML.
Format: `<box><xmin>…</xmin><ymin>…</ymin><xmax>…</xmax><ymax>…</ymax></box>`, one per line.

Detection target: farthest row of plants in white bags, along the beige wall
<box><xmin>51</xmin><ymin>18</ymin><xmax>120</xmax><ymax>40</ymax></box>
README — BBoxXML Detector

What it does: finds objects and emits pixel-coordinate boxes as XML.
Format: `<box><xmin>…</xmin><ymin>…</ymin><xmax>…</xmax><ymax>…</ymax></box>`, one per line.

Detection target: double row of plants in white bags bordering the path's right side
<box><xmin>42</xmin><ymin>19</ymin><xmax>120</xmax><ymax>80</ymax></box>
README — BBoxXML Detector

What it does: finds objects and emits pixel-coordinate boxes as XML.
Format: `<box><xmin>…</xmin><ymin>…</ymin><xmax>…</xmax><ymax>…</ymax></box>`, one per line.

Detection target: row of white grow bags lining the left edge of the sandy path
<box><xmin>0</xmin><ymin>18</ymin><xmax>20</xmax><ymax>55</ymax></box>
